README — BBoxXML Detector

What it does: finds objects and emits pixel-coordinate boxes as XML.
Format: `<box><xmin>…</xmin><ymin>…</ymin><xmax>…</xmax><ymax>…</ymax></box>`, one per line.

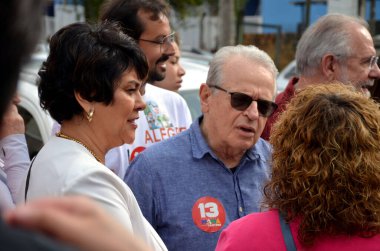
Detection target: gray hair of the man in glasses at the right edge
<box><xmin>296</xmin><ymin>14</ymin><xmax>368</xmax><ymax>76</ymax></box>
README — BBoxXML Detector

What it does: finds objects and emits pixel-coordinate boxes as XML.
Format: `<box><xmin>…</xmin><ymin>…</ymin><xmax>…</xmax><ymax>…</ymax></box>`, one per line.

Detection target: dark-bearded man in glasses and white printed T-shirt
<box><xmin>101</xmin><ymin>0</ymin><xmax>192</xmax><ymax>178</ymax></box>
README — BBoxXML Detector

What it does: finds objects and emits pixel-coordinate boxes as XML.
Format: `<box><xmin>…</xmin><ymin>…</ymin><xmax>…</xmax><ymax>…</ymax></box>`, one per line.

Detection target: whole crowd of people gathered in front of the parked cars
<box><xmin>0</xmin><ymin>0</ymin><xmax>380</xmax><ymax>251</ymax></box>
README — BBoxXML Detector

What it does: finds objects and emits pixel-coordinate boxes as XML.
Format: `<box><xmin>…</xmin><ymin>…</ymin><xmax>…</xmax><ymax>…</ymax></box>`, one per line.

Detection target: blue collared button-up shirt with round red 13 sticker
<box><xmin>124</xmin><ymin>117</ymin><xmax>271</xmax><ymax>251</ymax></box>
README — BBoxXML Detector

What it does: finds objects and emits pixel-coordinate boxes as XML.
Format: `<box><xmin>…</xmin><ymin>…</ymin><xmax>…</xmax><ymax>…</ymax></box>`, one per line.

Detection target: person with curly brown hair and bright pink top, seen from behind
<box><xmin>216</xmin><ymin>83</ymin><xmax>380</xmax><ymax>251</ymax></box>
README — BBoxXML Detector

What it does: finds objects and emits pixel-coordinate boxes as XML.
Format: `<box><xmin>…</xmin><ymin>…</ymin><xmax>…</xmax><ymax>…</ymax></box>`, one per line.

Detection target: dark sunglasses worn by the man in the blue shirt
<box><xmin>208</xmin><ymin>85</ymin><xmax>277</xmax><ymax>117</ymax></box>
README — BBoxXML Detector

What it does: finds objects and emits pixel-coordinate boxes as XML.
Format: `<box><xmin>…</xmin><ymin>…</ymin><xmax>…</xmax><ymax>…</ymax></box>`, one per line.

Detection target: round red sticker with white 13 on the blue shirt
<box><xmin>192</xmin><ymin>196</ymin><xmax>226</xmax><ymax>233</ymax></box>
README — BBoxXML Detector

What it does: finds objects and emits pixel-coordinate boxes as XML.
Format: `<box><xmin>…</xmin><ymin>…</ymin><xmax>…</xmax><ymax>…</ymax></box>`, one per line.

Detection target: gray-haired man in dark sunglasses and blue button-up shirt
<box><xmin>125</xmin><ymin>45</ymin><xmax>277</xmax><ymax>251</ymax></box>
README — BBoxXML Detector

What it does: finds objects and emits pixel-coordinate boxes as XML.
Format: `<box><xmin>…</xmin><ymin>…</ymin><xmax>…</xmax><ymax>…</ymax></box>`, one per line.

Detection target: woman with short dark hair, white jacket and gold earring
<box><xmin>25</xmin><ymin>22</ymin><xmax>166</xmax><ymax>250</ymax></box>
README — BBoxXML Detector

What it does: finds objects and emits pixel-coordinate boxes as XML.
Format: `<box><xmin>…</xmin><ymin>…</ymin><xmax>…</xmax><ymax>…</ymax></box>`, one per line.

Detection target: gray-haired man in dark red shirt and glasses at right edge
<box><xmin>261</xmin><ymin>14</ymin><xmax>380</xmax><ymax>140</ymax></box>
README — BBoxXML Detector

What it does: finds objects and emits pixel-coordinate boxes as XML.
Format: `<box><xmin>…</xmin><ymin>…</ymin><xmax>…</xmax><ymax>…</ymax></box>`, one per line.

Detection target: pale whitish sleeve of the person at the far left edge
<box><xmin>0</xmin><ymin>134</ymin><xmax>30</xmax><ymax>203</ymax></box>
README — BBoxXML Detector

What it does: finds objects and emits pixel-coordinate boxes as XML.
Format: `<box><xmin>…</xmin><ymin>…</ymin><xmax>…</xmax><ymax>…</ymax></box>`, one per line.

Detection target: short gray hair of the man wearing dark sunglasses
<box><xmin>207</xmin><ymin>45</ymin><xmax>278</xmax><ymax>92</ymax></box>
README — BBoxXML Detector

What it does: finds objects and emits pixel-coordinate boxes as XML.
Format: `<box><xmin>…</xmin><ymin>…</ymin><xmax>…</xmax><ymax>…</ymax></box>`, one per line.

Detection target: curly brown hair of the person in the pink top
<box><xmin>263</xmin><ymin>83</ymin><xmax>380</xmax><ymax>245</ymax></box>
